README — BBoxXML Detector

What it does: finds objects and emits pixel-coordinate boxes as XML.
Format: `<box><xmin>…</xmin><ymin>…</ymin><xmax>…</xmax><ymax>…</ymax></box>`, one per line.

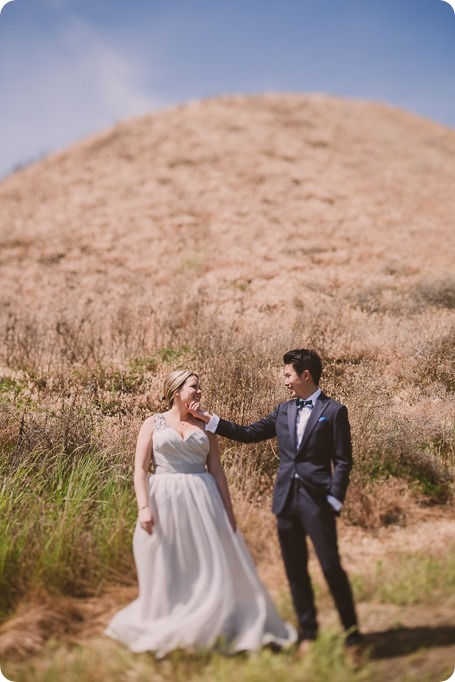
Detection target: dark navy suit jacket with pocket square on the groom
<box><xmin>216</xmin><ymin>393</ymin><xmax>352</xmax><ymax>514</ymax></box>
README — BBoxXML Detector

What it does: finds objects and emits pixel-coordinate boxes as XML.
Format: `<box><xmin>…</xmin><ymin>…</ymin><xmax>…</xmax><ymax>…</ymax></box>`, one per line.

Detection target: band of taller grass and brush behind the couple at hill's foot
<box><xmin>0</xmin><ymin>304</ymin><xmax>455</xmax><ymax>616</ymax></box>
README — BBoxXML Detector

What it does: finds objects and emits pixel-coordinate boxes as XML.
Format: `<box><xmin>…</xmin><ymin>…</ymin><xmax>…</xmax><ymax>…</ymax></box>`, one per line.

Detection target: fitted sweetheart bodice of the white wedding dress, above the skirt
<box><xmin>153</xmin><ymin>414</ymin><xmax>210</xmax><ymax>474</ymax></box>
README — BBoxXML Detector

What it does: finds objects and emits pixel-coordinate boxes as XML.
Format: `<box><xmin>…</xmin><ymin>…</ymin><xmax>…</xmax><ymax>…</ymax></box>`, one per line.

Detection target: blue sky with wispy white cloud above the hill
<box><xmin>0</xmin><ymin>0</ymin><xmax>455</xmax><ymax>177</ymax></box>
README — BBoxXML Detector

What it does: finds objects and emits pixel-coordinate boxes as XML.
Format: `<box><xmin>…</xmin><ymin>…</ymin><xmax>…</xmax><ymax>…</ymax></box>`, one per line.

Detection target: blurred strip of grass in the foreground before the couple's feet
<box><xmin>2</xmin><ymin>631</ymin><xmax>371</xmax><ymax>682</ymax></box>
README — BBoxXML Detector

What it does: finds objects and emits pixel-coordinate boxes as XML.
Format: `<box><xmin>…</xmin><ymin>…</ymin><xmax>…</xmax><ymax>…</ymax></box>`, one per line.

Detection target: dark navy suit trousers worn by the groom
<box><xmin>277</xmin><ymin>479</ymin><xmax>360</xmax><ymax>644</ymax></box>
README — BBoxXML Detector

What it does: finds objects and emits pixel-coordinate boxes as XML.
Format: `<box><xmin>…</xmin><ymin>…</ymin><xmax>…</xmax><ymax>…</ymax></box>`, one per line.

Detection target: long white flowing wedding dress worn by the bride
<box><xmin>105</xmin><ymin>415</ymin><xmax>297</xmax><ymax>656</ymax></box>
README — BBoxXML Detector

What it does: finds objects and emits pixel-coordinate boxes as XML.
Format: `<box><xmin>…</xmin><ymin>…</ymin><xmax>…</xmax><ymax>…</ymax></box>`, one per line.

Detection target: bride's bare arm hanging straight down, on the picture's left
<box><xmin>134</xmin><ymin>417</ymin><xmax>155</xmax><ymax>535</ymax></box>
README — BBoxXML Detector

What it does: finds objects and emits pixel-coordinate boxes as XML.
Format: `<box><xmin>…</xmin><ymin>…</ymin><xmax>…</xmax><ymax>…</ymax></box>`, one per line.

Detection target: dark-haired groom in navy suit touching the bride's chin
<box><xmin>191</xmin><ymin>348</ymin><xmax>361</xmax><ymax>661</ymax></box>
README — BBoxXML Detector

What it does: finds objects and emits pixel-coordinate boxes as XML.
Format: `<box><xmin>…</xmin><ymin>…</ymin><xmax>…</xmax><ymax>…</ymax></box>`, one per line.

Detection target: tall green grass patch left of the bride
<box><xmin>0</xmin><ymin>450</ymin><xmax>136</xmax><ymax>617</ymax></box>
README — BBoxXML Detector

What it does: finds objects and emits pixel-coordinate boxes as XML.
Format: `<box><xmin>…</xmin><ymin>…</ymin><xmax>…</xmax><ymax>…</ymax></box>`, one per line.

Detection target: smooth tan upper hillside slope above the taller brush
<box><xmin>0</xmin><ymin>94</ymin><xmax>455</xmax><ymax>326</ymax></box>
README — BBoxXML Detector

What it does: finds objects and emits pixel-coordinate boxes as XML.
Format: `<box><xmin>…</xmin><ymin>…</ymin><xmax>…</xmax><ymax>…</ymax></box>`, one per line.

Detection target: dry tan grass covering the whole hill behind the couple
<box><xmin>0</xmin><ymin>95</ymin><xmax>455</xmax><ymax>679</ymax></box>
